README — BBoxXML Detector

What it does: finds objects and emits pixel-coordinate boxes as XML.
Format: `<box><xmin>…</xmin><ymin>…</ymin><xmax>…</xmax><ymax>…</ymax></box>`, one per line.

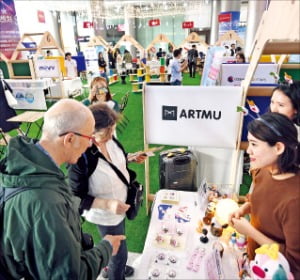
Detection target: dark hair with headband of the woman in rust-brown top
<box><xmin>248</xmin><ymin>113</ymin><xmax>300</xmax><ymax>173</ymax></box>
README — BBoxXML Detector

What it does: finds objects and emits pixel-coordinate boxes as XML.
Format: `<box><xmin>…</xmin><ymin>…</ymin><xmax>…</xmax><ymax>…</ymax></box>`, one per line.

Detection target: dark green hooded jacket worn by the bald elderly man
<box><xmin>0</xmin><ymin>137</ymin><xmax>112</xmax><ymax>279</ymax></box>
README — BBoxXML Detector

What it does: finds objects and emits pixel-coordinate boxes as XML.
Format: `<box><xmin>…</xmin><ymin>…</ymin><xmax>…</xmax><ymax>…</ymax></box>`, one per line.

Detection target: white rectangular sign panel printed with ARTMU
<box><xmin>144</xmin><ymin>85</ymin><xmax>242</xmax><ymax>148</ymax></box>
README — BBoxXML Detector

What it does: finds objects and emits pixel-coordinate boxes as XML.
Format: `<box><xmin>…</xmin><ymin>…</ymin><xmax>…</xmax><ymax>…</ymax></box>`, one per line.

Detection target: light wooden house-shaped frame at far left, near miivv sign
<box><xmin>7</xmin><ymin>31</ymin><xmax>64</xmax><ymax>79</ymax></box>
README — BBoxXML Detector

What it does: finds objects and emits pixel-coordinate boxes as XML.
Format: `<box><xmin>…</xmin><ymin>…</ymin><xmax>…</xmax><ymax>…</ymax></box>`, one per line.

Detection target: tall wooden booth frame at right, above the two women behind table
<box><xmin>232</xmin><ymin>0</ymin><xmax>300</xmax><ymax>187</ymax></box>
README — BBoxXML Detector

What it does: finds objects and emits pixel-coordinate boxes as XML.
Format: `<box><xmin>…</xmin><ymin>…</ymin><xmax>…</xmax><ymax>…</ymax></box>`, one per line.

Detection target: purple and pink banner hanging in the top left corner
<box><xmin>0</xmin><ymin>0</ymin><xmax>20</xmax><ymax>59</ymax></box>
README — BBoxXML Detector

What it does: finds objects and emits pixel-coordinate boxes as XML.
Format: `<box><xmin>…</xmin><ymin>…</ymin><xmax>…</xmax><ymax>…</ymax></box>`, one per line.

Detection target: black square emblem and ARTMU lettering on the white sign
<box><xmin>162</xmin><ymin>105</ymin><xmax>222</xmax><ymax>121</ymax></box>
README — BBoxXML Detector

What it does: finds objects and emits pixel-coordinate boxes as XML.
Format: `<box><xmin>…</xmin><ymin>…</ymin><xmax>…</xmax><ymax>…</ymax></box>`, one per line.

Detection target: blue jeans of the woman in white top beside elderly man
<box><xmin>98</xmin><ymin>219</ymin><xmax>128</xmax><ymax>280</ymax></box>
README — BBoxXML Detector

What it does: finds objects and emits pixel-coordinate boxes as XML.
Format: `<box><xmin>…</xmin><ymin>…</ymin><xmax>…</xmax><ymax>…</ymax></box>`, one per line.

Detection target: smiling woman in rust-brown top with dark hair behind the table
<box><xmin>229</xmin><ymin>113</ymin><xmax>300</xmax><ymax>279</ymax></box>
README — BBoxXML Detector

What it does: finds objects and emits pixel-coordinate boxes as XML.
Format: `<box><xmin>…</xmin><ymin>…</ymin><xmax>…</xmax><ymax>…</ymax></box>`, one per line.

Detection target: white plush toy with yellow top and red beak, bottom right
<box><xmin>250</xmin><ymin>244</ymin><xmax>294</xmax><ymax>280</ymax></box>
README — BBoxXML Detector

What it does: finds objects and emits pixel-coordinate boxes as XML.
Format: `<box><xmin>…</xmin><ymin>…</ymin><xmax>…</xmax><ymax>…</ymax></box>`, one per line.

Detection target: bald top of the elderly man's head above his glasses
<box><xmin>42</xmin><ymin>99</ymin><xmax>93</xmax><ymax>139</ymax></box>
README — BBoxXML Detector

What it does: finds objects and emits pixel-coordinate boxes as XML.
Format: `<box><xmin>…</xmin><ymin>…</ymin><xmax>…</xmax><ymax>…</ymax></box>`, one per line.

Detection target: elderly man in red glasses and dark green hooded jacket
<box><xmin>0</xmin><ymin>99</ymin><xmax>125</xmax><ymax>279</ymax></box>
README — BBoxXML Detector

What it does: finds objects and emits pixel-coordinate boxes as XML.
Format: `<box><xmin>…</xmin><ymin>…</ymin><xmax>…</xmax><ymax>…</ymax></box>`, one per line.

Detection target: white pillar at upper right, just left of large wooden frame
<box><xmin>245</xmin><ymin>0</ymin><xmax>266</xmax><ymax>57</ymax></box>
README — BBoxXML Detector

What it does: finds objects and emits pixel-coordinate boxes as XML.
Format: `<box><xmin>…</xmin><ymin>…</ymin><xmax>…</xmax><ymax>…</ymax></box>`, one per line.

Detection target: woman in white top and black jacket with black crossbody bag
<box><xmin>69</xmin><ymin>102</ymin><xmax>146</xmax><ymax>279</ymax></box>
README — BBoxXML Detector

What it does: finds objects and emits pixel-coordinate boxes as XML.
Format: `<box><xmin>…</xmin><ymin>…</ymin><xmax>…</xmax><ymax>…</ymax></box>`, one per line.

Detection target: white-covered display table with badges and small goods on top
<box><xmin>135</xmin><ymin>190</ymin><xmax>239</xmax><ymax>279</ymax></box>
